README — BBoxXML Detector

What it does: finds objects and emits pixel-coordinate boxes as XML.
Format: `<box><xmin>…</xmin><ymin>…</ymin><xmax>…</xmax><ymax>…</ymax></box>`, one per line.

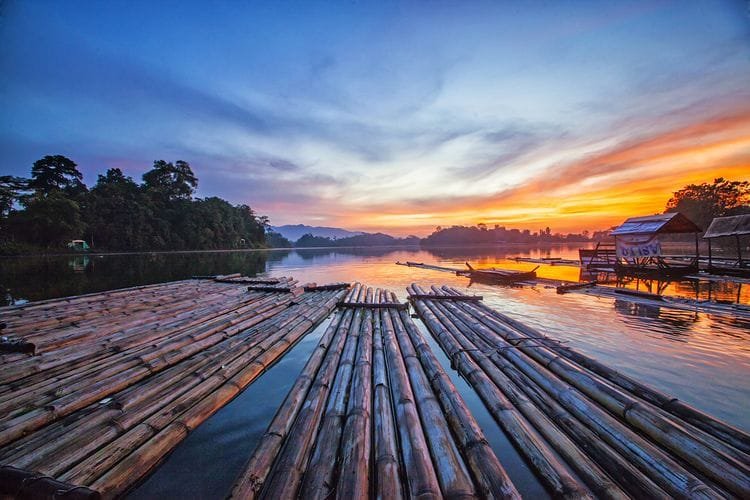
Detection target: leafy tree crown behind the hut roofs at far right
<box><xmin>665</xmin><ymin>177</ymin><xmax>750</xmax><ymax>230</ymax></box>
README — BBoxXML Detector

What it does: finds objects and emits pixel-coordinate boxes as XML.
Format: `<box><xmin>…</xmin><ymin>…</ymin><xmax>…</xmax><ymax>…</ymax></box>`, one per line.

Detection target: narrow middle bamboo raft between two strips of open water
<box><xmin>231</xmin><ymin>285</ymin><xmax>518</xmax><ymax>499</ymax></box>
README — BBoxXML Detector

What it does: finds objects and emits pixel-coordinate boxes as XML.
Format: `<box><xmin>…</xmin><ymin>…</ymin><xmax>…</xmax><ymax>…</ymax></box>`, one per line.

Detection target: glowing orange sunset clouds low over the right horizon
<box><xmin>335</xmin><ymin>108</ymin><xmax>750</xmax><ymax>235</ymax></box>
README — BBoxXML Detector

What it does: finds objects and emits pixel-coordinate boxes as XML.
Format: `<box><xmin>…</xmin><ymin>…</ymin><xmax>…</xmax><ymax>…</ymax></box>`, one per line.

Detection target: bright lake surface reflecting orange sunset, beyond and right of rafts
<box><xmin>254</xmin><ymin>245</ymin><xmax>750</xmax><ymax>429</ymax></box>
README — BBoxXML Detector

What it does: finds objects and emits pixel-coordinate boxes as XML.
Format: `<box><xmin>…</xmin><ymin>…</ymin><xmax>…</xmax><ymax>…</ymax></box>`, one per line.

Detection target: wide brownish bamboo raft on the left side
<box><xmin>0</xmin><ymin>276</ymin><xmax>348</xmax><ymax>498</ymax></box>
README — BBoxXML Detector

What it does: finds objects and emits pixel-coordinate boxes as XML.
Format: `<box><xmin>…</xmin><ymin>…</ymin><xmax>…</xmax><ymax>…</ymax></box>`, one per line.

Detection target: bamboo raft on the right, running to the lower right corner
<box><xmin>408</xmin><ymin>285</ymin><xmax>750</xmax><ymax>498</ymax></box>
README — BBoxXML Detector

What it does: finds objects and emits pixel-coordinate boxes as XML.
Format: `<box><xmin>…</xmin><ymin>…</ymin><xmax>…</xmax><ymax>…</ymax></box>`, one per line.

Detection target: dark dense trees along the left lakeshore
<box><xmin>0</xmin><ymin>155</ymin><xmax>290</xmax><ymax>253</ymax></box>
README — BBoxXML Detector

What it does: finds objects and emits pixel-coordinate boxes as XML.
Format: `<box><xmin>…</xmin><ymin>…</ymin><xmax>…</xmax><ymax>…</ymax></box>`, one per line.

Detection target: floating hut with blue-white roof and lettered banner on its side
<box><xmin>611</xmin><ymin>212</ymin><xmax>701</xmax><ymax>277</ymax></box>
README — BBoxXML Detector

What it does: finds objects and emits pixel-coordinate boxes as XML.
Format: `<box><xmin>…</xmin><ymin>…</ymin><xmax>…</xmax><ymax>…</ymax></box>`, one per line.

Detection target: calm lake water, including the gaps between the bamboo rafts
<box><xmin>0</xmin><ymin>246</ymin><xmax>750</xmax><ymax>498</ymax></box>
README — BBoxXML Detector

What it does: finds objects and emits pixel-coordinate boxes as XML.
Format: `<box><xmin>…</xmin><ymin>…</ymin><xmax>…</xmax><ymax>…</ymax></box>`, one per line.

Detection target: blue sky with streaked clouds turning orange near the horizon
<box><xmin>0</xmin><ymin>0</ymin><xmax>750</xmax><ymax>236</ymax></box>
